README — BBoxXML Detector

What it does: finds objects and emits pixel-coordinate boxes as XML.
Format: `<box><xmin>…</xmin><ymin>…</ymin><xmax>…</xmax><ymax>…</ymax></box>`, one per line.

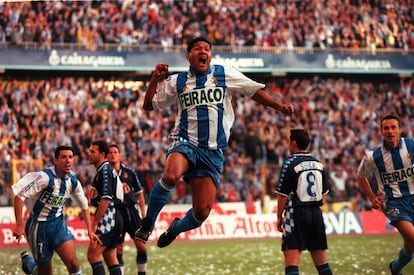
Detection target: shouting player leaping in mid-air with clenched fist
<box><xmin>135</xmin><ymin>37</ymin><xmax>294</xmax><ymax>247</ymax></box>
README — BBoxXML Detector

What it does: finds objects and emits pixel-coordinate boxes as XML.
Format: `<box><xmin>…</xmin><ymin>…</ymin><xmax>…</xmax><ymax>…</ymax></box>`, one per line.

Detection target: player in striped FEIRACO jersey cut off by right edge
<box><xmin>357</xmin><ymin>115</ymin><xmax>414</xmax><ymax>274</ymax></box>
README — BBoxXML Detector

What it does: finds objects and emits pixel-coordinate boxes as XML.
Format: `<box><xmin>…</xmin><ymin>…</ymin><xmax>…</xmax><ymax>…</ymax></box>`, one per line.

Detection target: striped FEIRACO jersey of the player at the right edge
<box><xmin>358</xmin><ymin>138</ymin><xmax>414</xmax><ymax>198</ymax></box>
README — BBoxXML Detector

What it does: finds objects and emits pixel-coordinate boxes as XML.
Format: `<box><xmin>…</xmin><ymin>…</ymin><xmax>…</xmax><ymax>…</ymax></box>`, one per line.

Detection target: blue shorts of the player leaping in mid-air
<box><xmin>167</xmin><ymin>136</ymin><xmax>224</xmax><ymax>189</ymax></box>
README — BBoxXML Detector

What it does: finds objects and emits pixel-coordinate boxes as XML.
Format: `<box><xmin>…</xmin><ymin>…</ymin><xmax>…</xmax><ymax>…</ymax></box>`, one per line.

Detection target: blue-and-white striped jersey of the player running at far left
<box><xmin>12</xmin><ymin>167</ymin><xmax>88</xmax><ymax>221</ymax></box>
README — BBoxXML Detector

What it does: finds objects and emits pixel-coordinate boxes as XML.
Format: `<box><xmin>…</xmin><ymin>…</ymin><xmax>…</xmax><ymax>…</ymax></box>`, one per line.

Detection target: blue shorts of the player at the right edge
<box><xmin>383</xmin><ymin>195</ymin><xmax>414</xmax><ymax>224</ymax></box>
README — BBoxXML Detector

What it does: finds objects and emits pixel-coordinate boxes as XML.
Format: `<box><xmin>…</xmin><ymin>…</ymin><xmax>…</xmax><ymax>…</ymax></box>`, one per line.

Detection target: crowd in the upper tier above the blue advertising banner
<box><xmin>0</xmin><ymin>0</ymin><xmax>414</xmax><ymax>50</ymax></box>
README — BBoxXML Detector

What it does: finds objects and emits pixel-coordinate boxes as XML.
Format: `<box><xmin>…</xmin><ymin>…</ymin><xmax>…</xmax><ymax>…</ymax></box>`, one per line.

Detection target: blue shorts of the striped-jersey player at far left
<box><xmin>25</xmin><ymin>215</ymin><xmax>74</xmax><ymax>263</ymax></box>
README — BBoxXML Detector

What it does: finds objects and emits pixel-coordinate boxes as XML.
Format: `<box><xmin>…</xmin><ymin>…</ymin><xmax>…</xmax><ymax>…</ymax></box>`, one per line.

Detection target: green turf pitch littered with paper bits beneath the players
<box><xmin>0</xmin><ymin>234</ymin><xmax>414</xmax><ymax>275</ymax></box>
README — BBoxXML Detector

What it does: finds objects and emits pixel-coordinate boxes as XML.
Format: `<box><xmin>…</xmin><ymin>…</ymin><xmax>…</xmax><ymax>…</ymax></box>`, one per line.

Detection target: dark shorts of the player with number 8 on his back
<box><xmin>282</xmin><ymin>207</ymin><xmax>328</xmax><ymax>251</ymax></box>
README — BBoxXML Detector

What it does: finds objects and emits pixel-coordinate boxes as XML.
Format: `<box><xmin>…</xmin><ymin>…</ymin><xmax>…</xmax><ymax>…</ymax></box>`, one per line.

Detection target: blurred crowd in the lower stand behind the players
<box><xmin>0</xmin><ymin>72</ymin><xmax>414</xmax><ymax>209</ymax></box>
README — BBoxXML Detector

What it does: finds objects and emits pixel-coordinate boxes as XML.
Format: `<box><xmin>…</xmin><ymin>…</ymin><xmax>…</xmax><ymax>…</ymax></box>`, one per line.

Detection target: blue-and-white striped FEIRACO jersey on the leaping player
<box><xmin>152</xmin><ymin>65</ymin><xmax>265</xmax><ymax>150</ymax></box>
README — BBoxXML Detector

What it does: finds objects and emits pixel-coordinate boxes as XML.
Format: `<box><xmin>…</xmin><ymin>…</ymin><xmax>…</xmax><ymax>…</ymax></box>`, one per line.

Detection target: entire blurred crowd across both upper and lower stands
<box><xmin>0</xmin><ymin>0</ymin><xmax>414</xmax><ymax>210</ymax></box>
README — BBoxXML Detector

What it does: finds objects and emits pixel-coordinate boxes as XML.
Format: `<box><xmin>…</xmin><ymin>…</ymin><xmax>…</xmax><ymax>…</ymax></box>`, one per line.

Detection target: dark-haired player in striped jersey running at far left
<box><xmin>12</xmin><ymin>145</ymin><xmax>100</xmax><ymax>274</ymax></box>
